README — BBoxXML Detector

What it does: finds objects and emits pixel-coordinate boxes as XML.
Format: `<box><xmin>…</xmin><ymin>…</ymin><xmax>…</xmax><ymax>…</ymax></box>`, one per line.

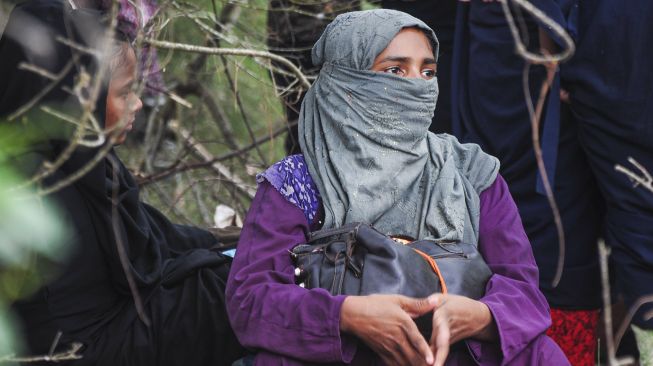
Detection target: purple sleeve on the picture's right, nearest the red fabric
<box><xmin>467</xmin><ymin>176</ymin><xmax>564</xmax><ymax>365</ymax></box>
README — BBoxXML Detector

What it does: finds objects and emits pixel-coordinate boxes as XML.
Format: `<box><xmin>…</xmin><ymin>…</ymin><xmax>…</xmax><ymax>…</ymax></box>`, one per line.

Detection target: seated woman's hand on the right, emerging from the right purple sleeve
<box><xmin>428</xmin><ymin>294</ymin><xmax>498</xmax><ymax>366</ymax></box>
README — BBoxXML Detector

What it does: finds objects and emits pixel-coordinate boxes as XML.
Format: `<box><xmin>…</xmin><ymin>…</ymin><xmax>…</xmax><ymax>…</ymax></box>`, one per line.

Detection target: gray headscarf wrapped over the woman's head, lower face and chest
<box><xmin>299</xmin><ymin>9</ymin><xmax>499</xmax><ymax>244</ymax></box>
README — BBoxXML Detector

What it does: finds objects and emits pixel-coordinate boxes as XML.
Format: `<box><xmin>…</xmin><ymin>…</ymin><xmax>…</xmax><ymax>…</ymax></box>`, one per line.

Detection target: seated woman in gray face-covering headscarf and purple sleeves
<box><xmin>227</xmin><ymin>10</ymin><xmax>568</xmax><ymax>365</ymax></box>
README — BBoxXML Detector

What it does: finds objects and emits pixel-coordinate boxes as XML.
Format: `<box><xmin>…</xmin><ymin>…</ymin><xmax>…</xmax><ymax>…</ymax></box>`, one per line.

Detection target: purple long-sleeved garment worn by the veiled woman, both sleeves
<box><xmin>227</xmin><ymin>159</ymin><xmax>568</xmax><ymax>365</ymax></box>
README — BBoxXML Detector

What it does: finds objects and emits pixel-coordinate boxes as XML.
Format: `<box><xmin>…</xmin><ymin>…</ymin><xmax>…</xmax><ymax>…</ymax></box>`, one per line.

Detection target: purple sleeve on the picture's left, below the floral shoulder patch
<box><xmin>226</xmin><ymin>181</ymin><xmax>356</xmax><ymax>365</ymax></box>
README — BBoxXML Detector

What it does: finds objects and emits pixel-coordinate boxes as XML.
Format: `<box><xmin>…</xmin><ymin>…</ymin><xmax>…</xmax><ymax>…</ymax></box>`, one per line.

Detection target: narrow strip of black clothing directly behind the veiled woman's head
<box><xmin>381</xmin><ymin>0</ymin><xmax>458</xmax><ymax>134</ymax></box>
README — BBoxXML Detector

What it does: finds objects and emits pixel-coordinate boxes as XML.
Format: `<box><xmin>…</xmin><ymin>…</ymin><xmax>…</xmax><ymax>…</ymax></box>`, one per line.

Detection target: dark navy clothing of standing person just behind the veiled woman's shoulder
<box><xmin>452</xmin><ymin>0</ymin><xmax>603</xmax><ymax>309</ymax></box>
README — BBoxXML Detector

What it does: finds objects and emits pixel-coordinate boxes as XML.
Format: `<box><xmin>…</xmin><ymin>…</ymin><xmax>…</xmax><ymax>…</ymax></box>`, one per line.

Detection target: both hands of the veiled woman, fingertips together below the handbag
<box><xmin>340</xmin><ymin>294</ymin><xmax>497</xmax><ymax>366</ymax></box>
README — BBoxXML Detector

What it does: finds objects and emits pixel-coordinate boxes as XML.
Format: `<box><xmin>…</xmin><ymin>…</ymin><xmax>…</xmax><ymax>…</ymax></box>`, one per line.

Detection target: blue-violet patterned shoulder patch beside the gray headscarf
<box><xmin>256</xmin><ymin>154</ymin><xmax>320</xmax><ymax>223</ymax></box>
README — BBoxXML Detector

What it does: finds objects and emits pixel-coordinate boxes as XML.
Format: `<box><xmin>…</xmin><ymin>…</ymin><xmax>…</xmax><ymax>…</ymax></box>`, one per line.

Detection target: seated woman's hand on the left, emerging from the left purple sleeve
<box><xmin>340</xmin><ymin>295</ymin><xmax>436</xmax><ymax>365</ymax></box>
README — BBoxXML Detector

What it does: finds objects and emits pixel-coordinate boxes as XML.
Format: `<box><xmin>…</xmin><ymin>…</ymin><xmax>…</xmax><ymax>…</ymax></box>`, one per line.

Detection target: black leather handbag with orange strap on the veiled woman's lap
<box><xmin>290</xmin><ymin>223</ymin><xmax>492</xmax><ymax>335</ymax></box>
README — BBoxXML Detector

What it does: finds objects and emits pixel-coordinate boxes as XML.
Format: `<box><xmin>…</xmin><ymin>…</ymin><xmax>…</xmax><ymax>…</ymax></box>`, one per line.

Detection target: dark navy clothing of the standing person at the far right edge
<box><xmin>561</xmin><ymin>0</ymin><xmax>653</xmax><ymax>329</ymax></box>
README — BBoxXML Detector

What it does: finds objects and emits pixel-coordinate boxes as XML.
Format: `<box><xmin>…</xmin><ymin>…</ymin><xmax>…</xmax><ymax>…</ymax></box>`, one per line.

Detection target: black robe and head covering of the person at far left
<box><xmin>0</xmin><ymin>0</ymin><xmax>242</xmax><ymax>365</ymax></box>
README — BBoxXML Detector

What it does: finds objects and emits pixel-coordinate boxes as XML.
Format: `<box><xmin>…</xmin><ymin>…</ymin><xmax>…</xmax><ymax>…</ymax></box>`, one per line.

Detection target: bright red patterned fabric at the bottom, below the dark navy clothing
<box><xmin>546</xmin><ymin>309</ymin><xmax>599</xmax><ymax>366</ymax></box>
